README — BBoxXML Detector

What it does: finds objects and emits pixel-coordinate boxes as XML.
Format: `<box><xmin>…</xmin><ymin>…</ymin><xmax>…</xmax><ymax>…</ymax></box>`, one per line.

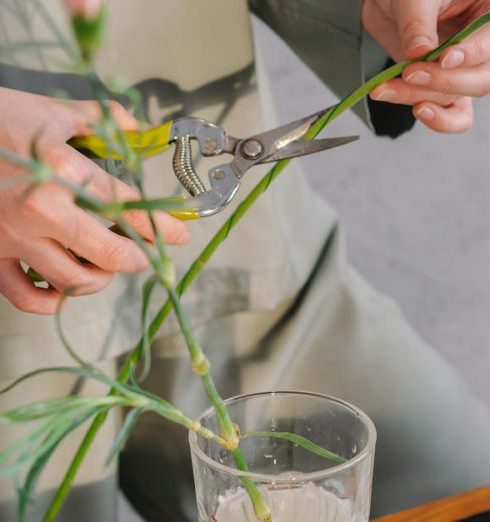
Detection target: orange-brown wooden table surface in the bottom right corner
<box><xmin>372</xmin><ymin>486</ymin><xmax>490</xmax><ymax>522</ymax></box>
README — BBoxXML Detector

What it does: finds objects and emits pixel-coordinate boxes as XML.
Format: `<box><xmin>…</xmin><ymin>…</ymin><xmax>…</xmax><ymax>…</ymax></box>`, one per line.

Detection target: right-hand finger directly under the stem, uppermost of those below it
<box><xmin>439</xmin><ymin>27</ymin><xmax>490</xmax><ymax>69</ymax></box>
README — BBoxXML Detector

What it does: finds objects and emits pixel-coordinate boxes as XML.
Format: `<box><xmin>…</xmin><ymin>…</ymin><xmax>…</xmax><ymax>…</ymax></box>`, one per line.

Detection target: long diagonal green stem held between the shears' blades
<box><xmin>44</xmin><ymin>13</ymin><xmax>490</xmax><ymax>522</ymax></box>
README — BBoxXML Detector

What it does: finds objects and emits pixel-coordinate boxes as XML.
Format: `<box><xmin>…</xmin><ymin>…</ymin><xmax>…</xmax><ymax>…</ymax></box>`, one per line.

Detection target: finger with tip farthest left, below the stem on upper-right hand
<box><xmin>370</xmin><ymin>78</ymin><xmax>457</xmax><ymax>107</ymax></box>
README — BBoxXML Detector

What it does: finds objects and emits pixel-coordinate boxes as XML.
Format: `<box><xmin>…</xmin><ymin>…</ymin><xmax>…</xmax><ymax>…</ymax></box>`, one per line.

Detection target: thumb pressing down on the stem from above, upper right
<box><xmin>392</xmin><ymin>0</ymin><xmax>440</xmax><ymax>58</ymax></box>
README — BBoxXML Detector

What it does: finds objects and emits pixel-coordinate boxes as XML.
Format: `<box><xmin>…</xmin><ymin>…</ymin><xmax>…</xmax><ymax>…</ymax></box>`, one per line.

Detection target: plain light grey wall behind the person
<box><xmin>121</xmin><ymin>14</ymin><xmax>490</xmax><ymax>522</ymax></box>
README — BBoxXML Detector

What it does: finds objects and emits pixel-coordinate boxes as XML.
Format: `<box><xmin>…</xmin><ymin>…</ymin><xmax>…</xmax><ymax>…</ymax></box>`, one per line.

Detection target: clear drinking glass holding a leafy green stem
<box><xmin>189</xmin><ymin>392</ymin><xmax>376</xmax><ymax>522</ymax></box>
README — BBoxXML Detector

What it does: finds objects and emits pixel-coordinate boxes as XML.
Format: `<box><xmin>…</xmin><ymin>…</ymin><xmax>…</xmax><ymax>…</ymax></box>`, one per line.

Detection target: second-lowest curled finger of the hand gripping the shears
<box><xmin>20</xmin><ymin>239</ymin><xmax>112</xmax><ymax>295</ymax></box>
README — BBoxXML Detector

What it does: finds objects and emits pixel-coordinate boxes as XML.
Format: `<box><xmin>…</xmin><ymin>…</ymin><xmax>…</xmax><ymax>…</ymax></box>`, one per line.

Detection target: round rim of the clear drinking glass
<box><xmin>189</xmin><ymin>390</ymin><xmax>376</xmax><ymax>484</ymax></box>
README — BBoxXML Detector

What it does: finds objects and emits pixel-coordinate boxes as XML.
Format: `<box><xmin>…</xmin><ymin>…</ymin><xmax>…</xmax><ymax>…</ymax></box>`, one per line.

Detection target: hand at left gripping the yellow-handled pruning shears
<box><xmin>0</xmin><ymin>88</ymin><xmax>188</xmax><ymax>314</ymax></box>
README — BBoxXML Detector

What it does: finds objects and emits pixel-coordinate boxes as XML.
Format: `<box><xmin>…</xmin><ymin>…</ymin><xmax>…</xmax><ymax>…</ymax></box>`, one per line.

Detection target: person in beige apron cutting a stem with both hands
<box><xmin>0</xmin><ymin>0</ymin><xmax>490</xmax><ymax>522</ymax></box>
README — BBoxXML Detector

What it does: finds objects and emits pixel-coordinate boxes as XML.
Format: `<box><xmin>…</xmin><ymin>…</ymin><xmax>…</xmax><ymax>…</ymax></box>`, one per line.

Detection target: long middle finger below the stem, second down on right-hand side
<box><xmin>403</xmin><ymin>63</ymin><xmax>490</xmax><ymax>97</ymax></box>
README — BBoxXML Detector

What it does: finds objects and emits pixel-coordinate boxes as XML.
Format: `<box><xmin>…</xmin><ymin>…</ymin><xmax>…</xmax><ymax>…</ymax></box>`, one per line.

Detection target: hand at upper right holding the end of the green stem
<box><xmin>362</xmin><ymin>0</ymin><xmax>490</xmax><ymax>132</ymax></box>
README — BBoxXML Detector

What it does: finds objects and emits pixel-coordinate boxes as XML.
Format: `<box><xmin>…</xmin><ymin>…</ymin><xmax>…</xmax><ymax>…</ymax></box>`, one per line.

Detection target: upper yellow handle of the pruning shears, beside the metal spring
<box><xmin>68</xmin><ymin>120</ymin><xmax>174</xmax><ymax>160</ymax></box>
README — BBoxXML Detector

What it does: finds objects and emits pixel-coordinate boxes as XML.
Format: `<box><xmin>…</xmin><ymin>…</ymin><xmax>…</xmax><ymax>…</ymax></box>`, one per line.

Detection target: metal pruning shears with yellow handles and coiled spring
<box><xmin>68</xmin><ymin>107</ymin><xmax>359</xmax><ymax>219</ymax></box>
